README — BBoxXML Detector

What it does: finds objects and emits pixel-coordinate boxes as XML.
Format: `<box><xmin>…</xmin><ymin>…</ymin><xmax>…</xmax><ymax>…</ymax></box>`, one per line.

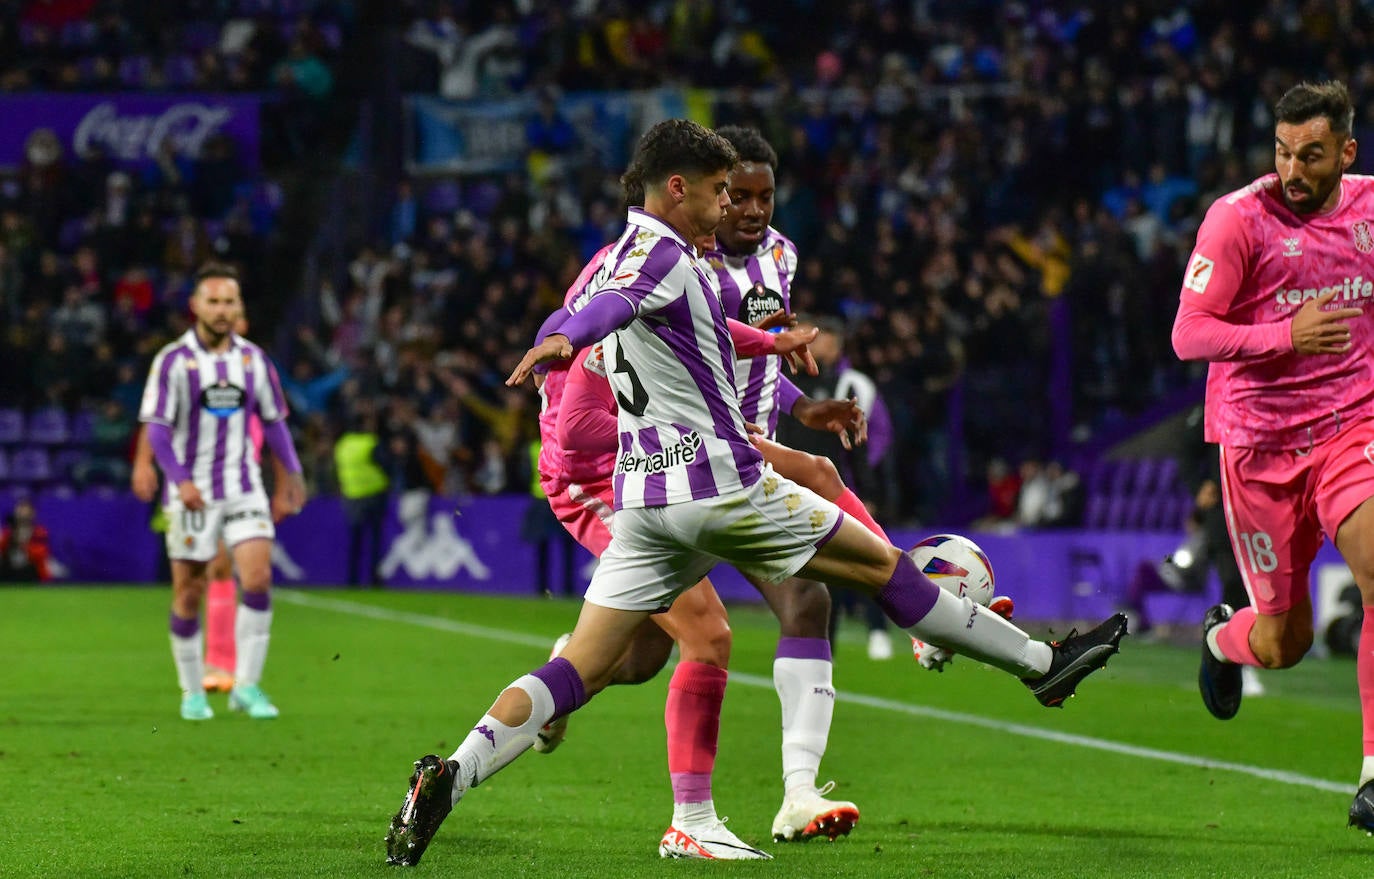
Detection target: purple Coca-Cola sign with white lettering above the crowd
<box><xmin>0</xmin><ymin>95</ymin><xmax>260</xmax><ymax>168</ymax></box>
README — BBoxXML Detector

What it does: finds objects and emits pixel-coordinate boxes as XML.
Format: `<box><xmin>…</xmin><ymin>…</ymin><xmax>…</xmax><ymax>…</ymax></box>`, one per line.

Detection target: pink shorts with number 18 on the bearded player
<box><xmin>1221</xmin><ymin>419</ymin><xmax>1374</xmax><ymax>615</ymax></box>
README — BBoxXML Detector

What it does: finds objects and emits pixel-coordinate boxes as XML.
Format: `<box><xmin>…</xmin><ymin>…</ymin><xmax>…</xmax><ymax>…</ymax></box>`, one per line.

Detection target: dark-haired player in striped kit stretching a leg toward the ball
<box><xmin>386</xmin><ymin>119</ymin><xmax>1127</xmax><ymax>865</ymax></box>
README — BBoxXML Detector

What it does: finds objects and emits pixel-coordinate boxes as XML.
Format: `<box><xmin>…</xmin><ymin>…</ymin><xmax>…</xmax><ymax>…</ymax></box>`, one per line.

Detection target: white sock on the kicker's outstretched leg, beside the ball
<box><xmin>907</xmin><ymin>589</ymin><xmax>1054</xmax><ymax>677</ymax></box>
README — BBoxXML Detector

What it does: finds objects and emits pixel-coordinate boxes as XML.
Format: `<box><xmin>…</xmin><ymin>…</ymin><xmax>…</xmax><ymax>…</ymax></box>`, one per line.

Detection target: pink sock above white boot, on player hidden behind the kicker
<box><xmin>664</xmin><ymin>662</ymin><xmax>728</xmax><ymax>803</ymax></box>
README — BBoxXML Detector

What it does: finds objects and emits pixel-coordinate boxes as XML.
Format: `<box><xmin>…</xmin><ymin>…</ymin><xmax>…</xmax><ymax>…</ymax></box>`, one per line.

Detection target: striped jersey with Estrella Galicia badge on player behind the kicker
<box><xmin>706</xmin><ymin>227</ymin><xmax>797</xmax><ymax>440</ymax></box>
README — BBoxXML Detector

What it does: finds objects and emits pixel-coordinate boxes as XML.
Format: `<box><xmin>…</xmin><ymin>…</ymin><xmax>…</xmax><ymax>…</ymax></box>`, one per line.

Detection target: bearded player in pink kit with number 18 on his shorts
<box><xmin>1173</xmin><ymin>82</ymin><xmax>1374</xmax><ymax>832</ymax></box>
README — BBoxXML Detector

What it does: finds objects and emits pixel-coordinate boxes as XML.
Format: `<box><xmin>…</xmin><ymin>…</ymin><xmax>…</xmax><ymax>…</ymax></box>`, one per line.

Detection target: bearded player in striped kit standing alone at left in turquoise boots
<box><xmin>139</xmin><ymin>262</ymin><xmax>305</xmax><ymax>720</ymax></box>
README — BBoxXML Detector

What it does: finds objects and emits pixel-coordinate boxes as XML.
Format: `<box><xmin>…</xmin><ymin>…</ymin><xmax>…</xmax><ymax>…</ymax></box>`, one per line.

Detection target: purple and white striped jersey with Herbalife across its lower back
<box><xmin>569</xmin><ymin>207</ymin><xmax>763</xmax><ymax>510</ymax></box>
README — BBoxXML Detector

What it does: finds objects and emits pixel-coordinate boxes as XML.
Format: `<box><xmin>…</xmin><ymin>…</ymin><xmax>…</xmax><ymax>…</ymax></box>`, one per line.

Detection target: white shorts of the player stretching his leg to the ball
<box><xmin>587</xmin><ymin>464</ymin><xmax>844</xmax><ymax>611</ymax></box>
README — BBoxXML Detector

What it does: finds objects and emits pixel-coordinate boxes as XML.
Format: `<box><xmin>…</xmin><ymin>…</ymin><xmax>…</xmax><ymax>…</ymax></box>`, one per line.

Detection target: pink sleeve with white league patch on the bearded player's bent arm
<box><xmin>1172</xmin><ymin>199</ymin><xmax>1293</xmax><ymax>361</ymax></box>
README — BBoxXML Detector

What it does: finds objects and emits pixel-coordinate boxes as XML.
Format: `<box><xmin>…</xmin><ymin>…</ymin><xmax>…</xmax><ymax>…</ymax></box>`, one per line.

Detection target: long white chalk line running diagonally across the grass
<box><xmin>273</xmin><ymin>589</ymin><xmax>1355</xmax><ymax>795</ymax></box>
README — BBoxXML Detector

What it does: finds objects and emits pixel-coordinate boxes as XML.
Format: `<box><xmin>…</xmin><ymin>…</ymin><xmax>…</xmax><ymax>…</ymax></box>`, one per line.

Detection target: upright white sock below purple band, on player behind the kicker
<box><xmin>774</xmin><ymin>657</ymin><xmax>835</xmax><ymax>791</ymax></box>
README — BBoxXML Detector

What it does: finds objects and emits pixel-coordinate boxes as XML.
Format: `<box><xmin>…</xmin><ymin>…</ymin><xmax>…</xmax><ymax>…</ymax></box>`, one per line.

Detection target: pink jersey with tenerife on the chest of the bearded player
<box><xmin>1173</xmin><ymin>174</ymin><xmax>1374</xmax><ymax>450</ymax></box>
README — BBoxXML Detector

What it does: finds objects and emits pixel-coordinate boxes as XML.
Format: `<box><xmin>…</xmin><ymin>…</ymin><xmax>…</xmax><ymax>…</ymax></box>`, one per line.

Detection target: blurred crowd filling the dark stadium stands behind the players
<box><xmin>0</xmin><ymin>0</ymin><xmax>1374</xmax><ymax>525</ymax></box>
